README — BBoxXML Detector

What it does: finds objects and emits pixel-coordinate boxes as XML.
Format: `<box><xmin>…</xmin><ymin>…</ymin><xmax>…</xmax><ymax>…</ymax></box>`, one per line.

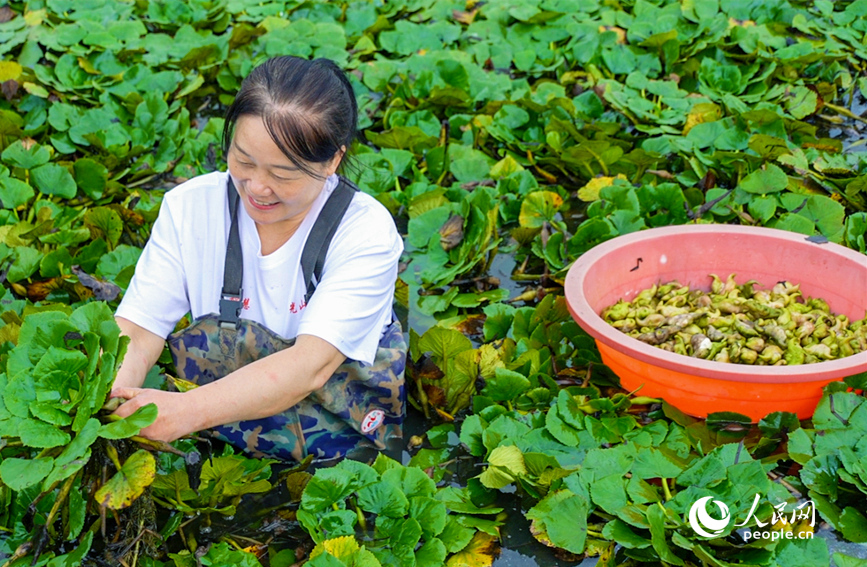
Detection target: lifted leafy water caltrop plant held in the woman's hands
<box><xmin>0</xmin><ymin>302</ymin><xmax>156</xmax><ymax>558</ymax></box>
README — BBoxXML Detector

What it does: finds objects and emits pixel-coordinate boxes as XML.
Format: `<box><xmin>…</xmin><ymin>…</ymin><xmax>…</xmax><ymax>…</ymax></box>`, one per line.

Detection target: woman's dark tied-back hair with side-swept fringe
<box><xmin>223</xmin><ymin>55</ymin><xmax>358</xmax><ymax>177</ymax></box>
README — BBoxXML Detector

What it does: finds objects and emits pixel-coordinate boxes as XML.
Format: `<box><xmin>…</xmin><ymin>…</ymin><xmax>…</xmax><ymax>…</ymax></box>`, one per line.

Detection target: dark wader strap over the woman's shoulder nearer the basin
<box><xmin>301</xmin><ymin>176</ymin><xmax>358</xmax><ymax>303</ymax></box>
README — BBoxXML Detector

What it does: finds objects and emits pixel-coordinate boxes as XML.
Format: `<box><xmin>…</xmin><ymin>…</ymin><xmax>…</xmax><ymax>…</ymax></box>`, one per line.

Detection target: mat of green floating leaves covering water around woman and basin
<box><xmin>0</xmin><ymin>0</ymin><xmax>867</xmax><ymax>567</ymax></box>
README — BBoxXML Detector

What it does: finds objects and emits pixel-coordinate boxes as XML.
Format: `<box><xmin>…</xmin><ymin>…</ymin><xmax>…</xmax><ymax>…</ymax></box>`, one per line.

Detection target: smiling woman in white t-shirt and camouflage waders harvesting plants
<box><xmin>112</xmin><ymin>57</ymin><xmax>406</xmax><ymax>459</ymax></box>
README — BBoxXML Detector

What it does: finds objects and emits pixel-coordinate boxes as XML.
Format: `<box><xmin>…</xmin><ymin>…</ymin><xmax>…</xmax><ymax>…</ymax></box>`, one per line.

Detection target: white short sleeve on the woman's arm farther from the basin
<box><xmin>116</xmin><ymin>194</ymin><xmax>190</xmax><ymax>337</ymax></box>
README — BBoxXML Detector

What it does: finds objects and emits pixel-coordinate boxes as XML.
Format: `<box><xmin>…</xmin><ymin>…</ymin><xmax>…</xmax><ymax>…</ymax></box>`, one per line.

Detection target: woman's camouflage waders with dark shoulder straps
<box><xmin>168</xmin><ymin>178</ymin><xmax>407</xmax><ymax>460</ymax></box>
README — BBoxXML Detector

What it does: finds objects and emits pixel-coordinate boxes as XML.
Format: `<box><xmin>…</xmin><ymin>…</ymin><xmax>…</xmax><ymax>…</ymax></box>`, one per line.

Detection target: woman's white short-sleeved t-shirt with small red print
<box><xmin>117</xmin><ymin>172</ymin><xmax>403</xmax><ymax>364</ymax></box>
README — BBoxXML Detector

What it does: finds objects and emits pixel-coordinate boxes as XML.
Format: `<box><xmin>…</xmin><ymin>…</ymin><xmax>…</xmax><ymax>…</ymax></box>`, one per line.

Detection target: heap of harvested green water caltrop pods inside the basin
<box><xmin>602</xmin><ymin>274</ymin><xmax>867</xmax><ymax>366</ymax></box>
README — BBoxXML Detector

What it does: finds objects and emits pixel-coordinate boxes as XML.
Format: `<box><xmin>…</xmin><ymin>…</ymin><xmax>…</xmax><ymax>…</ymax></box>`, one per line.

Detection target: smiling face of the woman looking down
<box><xmin>228</xmin><ymin>115</ymin><xmax>342</xmax><ymax>235</ymax></box>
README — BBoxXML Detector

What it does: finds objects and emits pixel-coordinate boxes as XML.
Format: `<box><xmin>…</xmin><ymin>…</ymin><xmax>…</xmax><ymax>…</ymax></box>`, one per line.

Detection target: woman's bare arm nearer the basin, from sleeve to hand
<box><xmin>112</xmin><ymin>335</ymin><xmax>346</xmax><ymax>441</ymax></box>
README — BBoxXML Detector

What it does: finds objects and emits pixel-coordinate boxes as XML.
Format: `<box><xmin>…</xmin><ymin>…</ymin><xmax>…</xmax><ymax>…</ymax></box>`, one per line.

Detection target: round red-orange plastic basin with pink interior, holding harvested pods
<box><xmin>566</xmin><ymin>224</ymin><xmax>867</xmax><ymax>421</ymax></box>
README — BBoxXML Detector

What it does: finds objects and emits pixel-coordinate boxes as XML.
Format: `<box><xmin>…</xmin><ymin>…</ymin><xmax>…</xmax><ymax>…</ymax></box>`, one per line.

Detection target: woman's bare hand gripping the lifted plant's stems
<box><xmin>111</xmin><ymin>388</ymin><xmax>198</xmax><ymax>443</ymax></box>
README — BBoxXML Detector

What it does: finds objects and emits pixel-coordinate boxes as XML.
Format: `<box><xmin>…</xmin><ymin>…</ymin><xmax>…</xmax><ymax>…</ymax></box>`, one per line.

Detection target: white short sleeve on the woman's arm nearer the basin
<box><xmin>298</xmin><ymin>200</ymin><xmax>403</xmax><ymax>364</ymax></box>
